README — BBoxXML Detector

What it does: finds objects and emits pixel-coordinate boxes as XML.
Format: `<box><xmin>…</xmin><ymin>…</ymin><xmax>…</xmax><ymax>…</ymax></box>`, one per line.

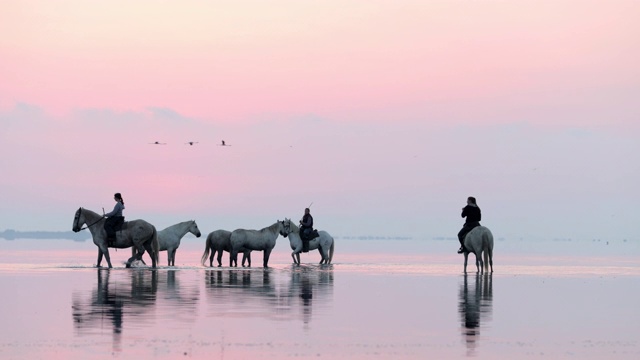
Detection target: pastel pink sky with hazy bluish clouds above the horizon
<box><xmin>0</xmin><ymin>0</ymin><xmax>640</xmax><ymax>239</ymax></box>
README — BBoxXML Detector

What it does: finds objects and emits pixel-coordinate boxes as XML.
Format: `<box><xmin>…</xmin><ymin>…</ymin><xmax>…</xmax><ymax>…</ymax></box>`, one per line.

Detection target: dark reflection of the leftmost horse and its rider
<box><xmin>72</xmin><ymin>269</ymin><xmax>158</xmax><ymax>350</ymax></box>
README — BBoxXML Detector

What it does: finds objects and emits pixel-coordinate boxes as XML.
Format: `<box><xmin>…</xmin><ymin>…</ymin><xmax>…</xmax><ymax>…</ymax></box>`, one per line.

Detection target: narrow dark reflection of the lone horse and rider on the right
<box><xmin>458</xmin><ymin>273</ymin><xmax>493</xmax><ymax>356</ymax></box>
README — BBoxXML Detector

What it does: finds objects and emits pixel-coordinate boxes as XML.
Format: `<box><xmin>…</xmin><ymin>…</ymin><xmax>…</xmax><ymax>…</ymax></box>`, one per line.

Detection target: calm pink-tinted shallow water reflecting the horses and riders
<box><xmin>0</xmin><ymin>239</ymin><xmax>640</xmax><ymax>359</ymax></box>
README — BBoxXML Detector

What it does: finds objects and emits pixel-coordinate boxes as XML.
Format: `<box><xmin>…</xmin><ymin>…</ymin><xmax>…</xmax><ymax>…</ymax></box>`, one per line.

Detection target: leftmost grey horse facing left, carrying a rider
<box><xmin>72</xmin><ymin>207</ymin><xmax>160</xmax><ymax>268</ymax></box>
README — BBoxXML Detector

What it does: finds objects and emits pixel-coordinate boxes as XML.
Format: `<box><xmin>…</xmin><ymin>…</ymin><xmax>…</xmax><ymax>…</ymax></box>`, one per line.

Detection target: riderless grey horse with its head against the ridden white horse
<box><xmin>229</xmin><ymin>220</ymin><xmax>284</xmax><ymax>268</ymax></box>
